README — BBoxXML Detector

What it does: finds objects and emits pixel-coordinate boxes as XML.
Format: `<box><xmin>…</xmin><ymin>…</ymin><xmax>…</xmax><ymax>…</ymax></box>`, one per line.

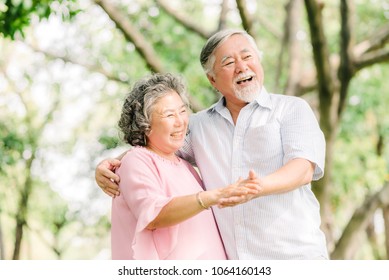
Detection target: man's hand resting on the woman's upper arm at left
<box><xmin>95</xmin><ymin>159</ymin><xmax>120</xmax><ymax>197</ymax></box>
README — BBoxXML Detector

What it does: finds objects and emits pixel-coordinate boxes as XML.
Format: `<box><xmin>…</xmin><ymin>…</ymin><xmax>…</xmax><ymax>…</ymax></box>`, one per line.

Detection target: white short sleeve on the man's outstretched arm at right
<box><xmin>281</xmin><ymin>98</ymin><xmax>326</xmax><ymax>180</ymax></box>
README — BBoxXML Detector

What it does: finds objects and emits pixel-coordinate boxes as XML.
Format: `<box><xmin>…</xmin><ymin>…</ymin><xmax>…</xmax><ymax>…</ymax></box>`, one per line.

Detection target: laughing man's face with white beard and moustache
<box><xmin>208</xmin><ymin>34</ymin><xmax>264</xmax><ymax>106</ymax></box>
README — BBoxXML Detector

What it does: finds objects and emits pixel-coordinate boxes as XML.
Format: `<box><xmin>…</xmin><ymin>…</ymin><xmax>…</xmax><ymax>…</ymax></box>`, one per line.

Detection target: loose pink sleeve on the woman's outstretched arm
<box><xmin>118</xmin><ymin>151</ymin><xmax>179</xmax><ymax>259</ymax></box>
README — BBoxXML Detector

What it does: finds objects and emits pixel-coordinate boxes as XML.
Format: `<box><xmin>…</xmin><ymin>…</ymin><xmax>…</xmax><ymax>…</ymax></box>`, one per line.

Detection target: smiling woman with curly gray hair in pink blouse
<box><xmin>111</xmin><ymin>74</ymin><xmax>257</xmax><ymax>260</ymax></box>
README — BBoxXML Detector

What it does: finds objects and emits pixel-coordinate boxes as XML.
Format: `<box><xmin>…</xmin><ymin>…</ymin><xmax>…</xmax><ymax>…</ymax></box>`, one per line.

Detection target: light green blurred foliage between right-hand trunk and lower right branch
<box><xmin>331</xmin><ymin>65</ymin><xmax>389</xmax><ymax>233</ymax></box>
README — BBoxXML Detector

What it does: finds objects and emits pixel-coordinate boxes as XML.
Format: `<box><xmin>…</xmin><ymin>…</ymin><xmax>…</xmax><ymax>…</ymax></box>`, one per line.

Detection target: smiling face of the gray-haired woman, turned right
<box><xmin>147</xmin><ymin>91</ymin><xmax>189</xmax><ymax>155</ymax></box>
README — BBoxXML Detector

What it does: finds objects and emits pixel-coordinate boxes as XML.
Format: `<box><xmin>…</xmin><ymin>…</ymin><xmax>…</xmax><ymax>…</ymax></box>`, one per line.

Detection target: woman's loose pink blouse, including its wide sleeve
<box><xmin>111</xmin><ymin>147</ymin><xmax>226</xmax><ymax>260</ymax></box>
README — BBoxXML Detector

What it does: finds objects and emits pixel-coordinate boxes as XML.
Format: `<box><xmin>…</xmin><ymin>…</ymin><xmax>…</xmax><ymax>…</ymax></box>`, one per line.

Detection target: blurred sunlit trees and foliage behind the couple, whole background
<box><xmin>0</xmin><ymin>0</ymin><xmax>389</xmax><ymax>260</ymax></box>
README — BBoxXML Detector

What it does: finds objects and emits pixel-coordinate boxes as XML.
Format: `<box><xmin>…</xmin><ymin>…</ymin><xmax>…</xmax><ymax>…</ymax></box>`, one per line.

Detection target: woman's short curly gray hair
<box><xmin>118</xmin><ymin>73</ymin><xmax>189</xmax><ymax>146</ymax></box>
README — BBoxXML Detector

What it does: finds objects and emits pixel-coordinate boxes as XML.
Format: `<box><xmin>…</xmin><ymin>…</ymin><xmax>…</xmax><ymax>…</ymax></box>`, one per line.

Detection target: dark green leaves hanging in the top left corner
<box><xmin>0</xmin><ymin>0</ymin><xmax>77</xmax><ymax>39</ymax></box>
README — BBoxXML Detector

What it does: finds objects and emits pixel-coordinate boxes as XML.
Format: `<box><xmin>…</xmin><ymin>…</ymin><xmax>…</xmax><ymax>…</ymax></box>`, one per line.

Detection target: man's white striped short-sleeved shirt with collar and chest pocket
<box><xmin>180</xmin><ymin>88</ymin><xmax>328</xmax><ymax>259</ymax></box>
